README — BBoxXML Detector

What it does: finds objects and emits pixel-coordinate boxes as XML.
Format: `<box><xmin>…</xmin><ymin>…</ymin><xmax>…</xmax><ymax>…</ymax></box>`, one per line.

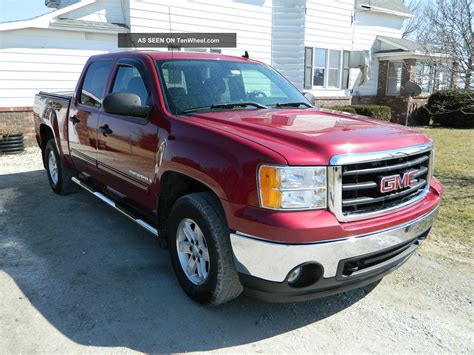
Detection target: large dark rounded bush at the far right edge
<box><xmin>426</xmin><ymin>90</ymin><xmax>474</xmax><ymax>128</ymax></box>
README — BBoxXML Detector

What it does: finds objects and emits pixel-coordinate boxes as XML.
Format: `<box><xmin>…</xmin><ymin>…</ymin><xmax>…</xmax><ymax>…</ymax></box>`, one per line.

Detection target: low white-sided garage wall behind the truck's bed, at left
<box><xmin>0</xmin><ymin>29</ymin><xmax>117</xmax><ymax>107</ymax></box>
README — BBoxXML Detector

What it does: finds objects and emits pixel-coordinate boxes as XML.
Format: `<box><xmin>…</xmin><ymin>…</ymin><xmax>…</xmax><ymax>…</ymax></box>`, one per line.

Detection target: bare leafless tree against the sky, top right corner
<box><xmin>417</xmin><ymin>0</ymin><xmax>474</xmax><ymax>90</ymax></box>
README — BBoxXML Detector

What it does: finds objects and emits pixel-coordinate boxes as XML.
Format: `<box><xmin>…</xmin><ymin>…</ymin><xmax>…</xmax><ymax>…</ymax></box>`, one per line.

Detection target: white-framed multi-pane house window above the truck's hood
<box><xmin>304</xmin><ymin>47</ymin><xmax>350</xmax><ymax>89</ymax></box>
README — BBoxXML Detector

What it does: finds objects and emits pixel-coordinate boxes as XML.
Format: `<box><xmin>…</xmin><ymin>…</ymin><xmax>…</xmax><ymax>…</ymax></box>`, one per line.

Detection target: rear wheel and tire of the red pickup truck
<box><xmin>44</xmin><ymin>139</ymin><xmax>77</xmax><ymax>195</ymax></box>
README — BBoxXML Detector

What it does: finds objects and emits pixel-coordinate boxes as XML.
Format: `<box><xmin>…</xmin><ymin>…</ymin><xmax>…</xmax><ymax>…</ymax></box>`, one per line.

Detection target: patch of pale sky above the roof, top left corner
<box><xmin>0</xmin><ymin>0</ymin><xmax>54</xmax><ymax>22</ymax></box>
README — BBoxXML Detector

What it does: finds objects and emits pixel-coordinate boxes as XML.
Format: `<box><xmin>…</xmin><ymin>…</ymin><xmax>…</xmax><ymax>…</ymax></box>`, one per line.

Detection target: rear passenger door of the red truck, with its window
<box><xmin>68</xmin><ymin>59</ymin><xmax>113</xmax><ymax>172</ymax></box>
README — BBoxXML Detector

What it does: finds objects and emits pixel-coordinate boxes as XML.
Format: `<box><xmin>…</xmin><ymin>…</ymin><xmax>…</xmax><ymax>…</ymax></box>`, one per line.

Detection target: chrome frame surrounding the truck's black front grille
<box><xmin>327</xmin><ymin>142</ymin><xmax>433</xmax><ymax>222</ymax></box>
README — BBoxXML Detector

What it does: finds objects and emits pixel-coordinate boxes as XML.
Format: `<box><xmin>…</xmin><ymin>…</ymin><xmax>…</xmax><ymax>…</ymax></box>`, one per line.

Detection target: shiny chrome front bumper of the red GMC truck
<box><xmin>230</xmin><ymin>208</ymin><xmax>438</xmax><ymax>282</ymax></box>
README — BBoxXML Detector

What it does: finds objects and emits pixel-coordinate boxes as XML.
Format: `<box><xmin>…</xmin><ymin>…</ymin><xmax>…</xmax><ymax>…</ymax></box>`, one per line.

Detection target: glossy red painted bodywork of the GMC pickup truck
<box><xmin>35</xmin><ymin>51</ymin><xmax>442</xmax><ymax>243</ymax></box>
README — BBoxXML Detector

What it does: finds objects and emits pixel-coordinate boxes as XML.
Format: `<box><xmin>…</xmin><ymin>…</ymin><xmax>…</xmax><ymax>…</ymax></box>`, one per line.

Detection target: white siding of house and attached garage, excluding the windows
<box><xmin>0</xmin><ymin>0</ymin><xmax>412</xmax><ymax>107</ymax></box>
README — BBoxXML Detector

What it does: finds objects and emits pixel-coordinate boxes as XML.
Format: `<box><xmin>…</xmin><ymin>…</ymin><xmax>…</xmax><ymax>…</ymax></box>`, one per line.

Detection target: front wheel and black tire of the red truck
<box><xmin>167</xmin><ymin>192</ymin><xmax>243</xmax><ymax>306</ymax></box>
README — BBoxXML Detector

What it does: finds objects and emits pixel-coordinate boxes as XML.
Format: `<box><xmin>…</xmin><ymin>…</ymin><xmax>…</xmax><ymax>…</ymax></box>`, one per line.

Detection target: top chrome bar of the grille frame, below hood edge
<box><xmin>329</xmin><ymin>142</ymin><xmax>433</xmax><ymax>165</ymax></box>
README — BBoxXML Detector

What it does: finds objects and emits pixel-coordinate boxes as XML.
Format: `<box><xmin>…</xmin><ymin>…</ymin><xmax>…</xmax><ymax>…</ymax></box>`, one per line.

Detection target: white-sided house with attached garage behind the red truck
<box><xmin>0</xmin><ymin>0</ymin><xmax>454</xmax><ymax>143</ymax></box>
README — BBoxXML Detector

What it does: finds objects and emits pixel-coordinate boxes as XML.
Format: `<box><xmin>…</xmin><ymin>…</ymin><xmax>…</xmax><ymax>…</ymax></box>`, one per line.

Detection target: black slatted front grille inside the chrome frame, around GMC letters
<box><xmin>342</xmin><ymin>151</ymin><xmax>430</xmax><ymax>215</ymax></box>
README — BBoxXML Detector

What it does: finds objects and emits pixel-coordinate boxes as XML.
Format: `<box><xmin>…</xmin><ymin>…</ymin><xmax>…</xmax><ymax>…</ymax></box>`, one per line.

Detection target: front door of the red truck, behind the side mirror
<box><xmin>97</xmin><ymin>58</ymin><xmax>158</xmax><ymax>207</ymax></box>
